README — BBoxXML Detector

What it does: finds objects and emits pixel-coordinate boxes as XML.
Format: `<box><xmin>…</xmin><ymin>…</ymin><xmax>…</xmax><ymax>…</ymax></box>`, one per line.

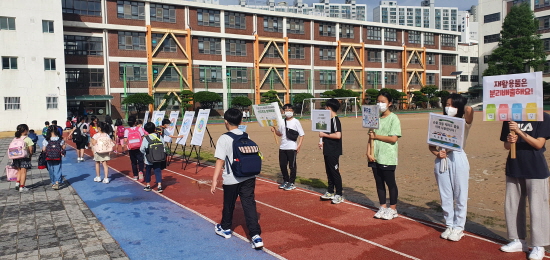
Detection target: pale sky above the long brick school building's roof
<box><xmin>219</xmin><ymin>0</ymin><xmax>477</xmax><ymax>21</ymax></box>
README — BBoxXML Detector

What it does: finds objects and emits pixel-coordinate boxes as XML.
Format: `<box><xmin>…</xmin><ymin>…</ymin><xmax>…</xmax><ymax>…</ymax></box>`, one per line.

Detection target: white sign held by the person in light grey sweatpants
<box><xmin>428</xmin><ymin>113</ymin><xmax>466</xmax><ymax>151</ymax></box>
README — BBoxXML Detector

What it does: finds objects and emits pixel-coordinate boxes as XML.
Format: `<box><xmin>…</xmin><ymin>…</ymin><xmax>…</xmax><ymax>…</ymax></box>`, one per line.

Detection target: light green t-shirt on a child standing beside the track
<box><xmin>374</xmin><ymin>113</ymin><xmax>401</xmax><ymax>165</ymax></box>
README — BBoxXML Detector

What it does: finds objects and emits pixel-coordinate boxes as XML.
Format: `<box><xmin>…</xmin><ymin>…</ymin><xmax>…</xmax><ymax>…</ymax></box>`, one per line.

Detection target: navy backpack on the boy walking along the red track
<box><xmin>225</xmin><ymin>132</ymin><xmax>262</xmax><ymax>177</ymax></box>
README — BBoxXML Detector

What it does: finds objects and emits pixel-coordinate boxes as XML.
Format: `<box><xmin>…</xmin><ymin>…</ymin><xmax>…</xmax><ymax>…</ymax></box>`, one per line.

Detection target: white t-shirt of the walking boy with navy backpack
<box><xmin>214</xmin><ymin>129</ymin><xmax>256</xmax><ymax>185</ymax></box>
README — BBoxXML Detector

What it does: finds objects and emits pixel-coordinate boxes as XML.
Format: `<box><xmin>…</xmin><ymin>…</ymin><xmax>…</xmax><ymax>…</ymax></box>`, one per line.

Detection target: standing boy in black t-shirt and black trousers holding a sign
<box><xmin>319</xmin><ymin>98</ymin><xmax>344</xmax><ymax>204</ymax></box>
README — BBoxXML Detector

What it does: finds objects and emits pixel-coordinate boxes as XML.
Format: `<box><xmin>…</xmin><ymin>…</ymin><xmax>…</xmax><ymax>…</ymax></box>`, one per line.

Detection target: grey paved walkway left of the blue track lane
<box><xmin>0</xmin><ymin>138</ymin><xmax>129</xmax><ymax>260</ymax></box>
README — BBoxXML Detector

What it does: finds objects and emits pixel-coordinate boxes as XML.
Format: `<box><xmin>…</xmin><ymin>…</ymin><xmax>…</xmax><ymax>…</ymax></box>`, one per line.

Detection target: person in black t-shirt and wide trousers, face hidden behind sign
<box><xmin>500</xmin><ymin>113</ymin><xmax>550</xmax><ymax>260</ymax></box>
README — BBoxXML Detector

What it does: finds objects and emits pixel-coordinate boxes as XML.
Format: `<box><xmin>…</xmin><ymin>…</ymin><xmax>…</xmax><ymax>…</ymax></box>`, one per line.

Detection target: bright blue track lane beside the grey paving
<box><xmin>61</xmin><ymin>144</ymin><xmax>274</xmax><ymax>260</ymax></box>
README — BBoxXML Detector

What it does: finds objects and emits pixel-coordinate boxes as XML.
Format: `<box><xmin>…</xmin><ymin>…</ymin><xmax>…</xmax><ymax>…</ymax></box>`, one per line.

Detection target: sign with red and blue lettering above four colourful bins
<box><xmin>483</xmin><ymin>71</ymin><xmax>544</xmax><ymax>121</ymax></box>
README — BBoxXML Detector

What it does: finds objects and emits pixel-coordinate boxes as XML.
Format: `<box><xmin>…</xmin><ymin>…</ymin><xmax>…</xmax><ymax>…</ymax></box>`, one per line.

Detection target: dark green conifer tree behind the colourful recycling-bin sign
<box><xmin>483</xmin><ymin>2</ymin><xmax>546</xmax><ymax>76</ymax></box>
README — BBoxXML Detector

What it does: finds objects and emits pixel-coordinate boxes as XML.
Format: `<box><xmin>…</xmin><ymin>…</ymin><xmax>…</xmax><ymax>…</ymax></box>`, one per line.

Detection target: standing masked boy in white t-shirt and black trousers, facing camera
<box><xmin>271</xmin><ymin>104</ymin><xmax>305</xmax><ymax>190</ymax></box>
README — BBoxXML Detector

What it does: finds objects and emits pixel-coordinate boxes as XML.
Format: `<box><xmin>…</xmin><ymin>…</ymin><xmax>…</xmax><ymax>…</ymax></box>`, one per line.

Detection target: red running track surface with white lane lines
<box><xmin>75</xmin><ymin>143</ymin><xmax>549</xmax><ymax>260</ymax></box>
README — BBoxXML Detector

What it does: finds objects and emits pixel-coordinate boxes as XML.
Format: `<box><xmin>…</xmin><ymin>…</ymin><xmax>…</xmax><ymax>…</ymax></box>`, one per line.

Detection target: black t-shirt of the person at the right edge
<box><xmin>500</xmin><ymin>113</ymin><xmax>550</xmax><ymax>179</ymax></box>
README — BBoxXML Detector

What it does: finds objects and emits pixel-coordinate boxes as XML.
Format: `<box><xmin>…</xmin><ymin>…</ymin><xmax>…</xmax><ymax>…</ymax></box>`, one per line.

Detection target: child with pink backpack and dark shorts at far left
<box><xmin>11</xmin><ymin>124</ymin><xmax>33</xmax><ymax>192</ymax></box>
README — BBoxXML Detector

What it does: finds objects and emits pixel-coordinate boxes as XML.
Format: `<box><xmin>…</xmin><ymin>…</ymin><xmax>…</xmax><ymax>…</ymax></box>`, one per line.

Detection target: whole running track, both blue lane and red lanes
<box><xmin>63</xmin><ymin>138</ymin><xmax>550</xmax><ymax>260</ymax></box>
